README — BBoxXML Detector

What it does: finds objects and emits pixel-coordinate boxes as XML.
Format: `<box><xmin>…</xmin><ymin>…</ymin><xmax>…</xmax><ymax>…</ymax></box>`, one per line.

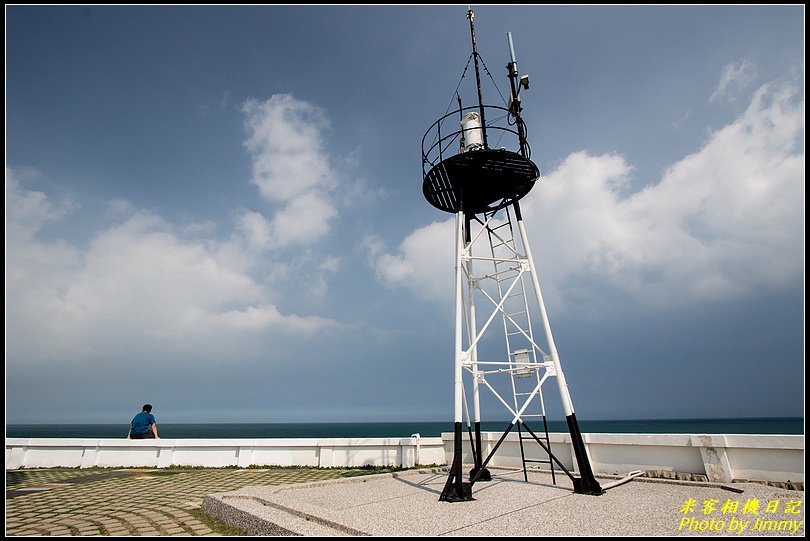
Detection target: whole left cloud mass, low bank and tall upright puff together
<box><xmin>6</xmin><ymin>95</ymin><xmax>354</xmax><ymax>376</ymax></box>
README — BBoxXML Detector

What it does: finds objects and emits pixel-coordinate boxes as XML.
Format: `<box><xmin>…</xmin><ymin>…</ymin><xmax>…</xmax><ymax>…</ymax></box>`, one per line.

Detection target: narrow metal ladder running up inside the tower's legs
<box><xmin>485</xmin><ymin>207</ymin><xmax>557</xmax><ymax>485</ymax></box>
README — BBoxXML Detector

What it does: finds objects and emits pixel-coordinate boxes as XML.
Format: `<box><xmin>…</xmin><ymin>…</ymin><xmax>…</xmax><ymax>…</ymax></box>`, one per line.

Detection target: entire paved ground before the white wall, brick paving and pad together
<box><xmin>6</xmin><ymin>469</ymin><xmax>804</xmax><ymax>536</ymax></box>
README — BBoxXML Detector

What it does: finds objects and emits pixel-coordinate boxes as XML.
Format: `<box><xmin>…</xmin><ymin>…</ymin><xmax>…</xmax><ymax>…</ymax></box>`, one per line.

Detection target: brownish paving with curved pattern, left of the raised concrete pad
<box><xmin>5</xmin><ymin>469</ymin><xmax>376</xmax><ymax>536</ymax></box>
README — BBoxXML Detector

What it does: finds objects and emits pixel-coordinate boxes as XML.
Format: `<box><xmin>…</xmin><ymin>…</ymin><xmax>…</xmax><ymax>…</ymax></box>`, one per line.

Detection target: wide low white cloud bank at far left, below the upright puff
<box><xmin>6</xmin><ymin>173</ymin><xmax>339</xmax><ymax>366</ymax></box>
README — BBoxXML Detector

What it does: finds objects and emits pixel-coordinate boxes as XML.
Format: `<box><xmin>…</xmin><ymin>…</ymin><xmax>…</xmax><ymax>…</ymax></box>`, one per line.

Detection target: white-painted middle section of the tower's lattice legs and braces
<box><xmin>454</xmin><ymin>209</ymin><xmax>574</xmax><ymax>434</ymax></box>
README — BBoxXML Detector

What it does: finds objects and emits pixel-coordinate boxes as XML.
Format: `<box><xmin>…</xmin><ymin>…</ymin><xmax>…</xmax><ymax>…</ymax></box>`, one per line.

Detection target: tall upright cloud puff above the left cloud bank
<box><xmin>242</xmin><ymin>94</ymin><xmax>338</xmax><ymax>247</ymax></box>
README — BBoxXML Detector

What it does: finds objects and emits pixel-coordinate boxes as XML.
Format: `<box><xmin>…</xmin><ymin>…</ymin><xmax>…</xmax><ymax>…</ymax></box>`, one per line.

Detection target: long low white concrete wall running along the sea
<box><xmin>6</xmin><ymin>432</ymin><xmax>804</xmax><ymax>483</ymax></box>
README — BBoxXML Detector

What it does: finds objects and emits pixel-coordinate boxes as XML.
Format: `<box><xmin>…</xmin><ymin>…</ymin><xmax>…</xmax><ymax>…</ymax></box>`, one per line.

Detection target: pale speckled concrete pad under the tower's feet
<box><xmin>202</xmin><ymin>469</ymin><xmax>804</xmax><ymax>536</ymax></box>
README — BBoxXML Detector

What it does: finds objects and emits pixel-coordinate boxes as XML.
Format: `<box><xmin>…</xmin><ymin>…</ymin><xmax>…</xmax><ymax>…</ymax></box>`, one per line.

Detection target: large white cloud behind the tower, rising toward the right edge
<box><xmin>367</xmin><ymin>81</ymin><xmax>804</xmax><ymax>308</ymax></box>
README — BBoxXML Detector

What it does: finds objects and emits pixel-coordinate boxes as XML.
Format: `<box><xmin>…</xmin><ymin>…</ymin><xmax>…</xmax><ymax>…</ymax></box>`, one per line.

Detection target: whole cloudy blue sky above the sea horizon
<box><xmin>5</xmin><ymin>5</ymin><xmax>805</xmax><ymax>424</ymax></box>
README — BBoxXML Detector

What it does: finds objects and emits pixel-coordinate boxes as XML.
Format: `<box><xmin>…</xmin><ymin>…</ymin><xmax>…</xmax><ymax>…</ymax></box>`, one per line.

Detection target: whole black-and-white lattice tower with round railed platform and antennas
<box><xmin>422</xmin><ymin>10</ymin><xmax>603</xmax><ymax>502</ymax></box>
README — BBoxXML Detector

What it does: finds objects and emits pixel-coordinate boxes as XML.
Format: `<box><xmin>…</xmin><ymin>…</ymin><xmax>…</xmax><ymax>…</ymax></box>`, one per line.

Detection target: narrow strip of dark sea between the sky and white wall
<box><xmin>6</xmin><ymin>417</ymin><xmax>804</xmax><ymax>439</ymax></box>
